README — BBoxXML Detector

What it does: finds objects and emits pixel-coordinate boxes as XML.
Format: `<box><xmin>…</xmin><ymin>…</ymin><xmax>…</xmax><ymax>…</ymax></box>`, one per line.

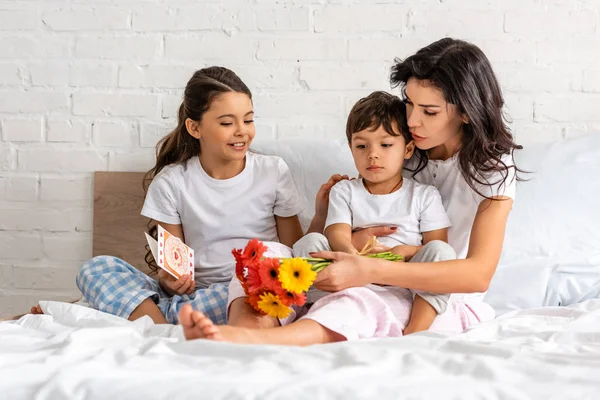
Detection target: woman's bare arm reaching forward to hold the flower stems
<box><xmin>314</xmin><ymin>196</ymin><xmax>513</xmax><ymax>293</ymax></box>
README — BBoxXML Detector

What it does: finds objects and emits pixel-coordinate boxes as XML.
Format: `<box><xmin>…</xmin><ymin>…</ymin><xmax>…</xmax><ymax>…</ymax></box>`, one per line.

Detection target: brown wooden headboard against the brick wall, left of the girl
<box><xmin>92</xmin><ymin>172</ymin><xmax>149</xmax><ymax>273</ymax></box>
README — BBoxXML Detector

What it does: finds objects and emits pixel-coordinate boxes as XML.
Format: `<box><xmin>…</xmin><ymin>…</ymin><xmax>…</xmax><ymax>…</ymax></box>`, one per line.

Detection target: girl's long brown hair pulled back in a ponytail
<box><xmin>143</xmin><ymin>67</ymin><xmax>252</xmax><ymax>273</ymax></box>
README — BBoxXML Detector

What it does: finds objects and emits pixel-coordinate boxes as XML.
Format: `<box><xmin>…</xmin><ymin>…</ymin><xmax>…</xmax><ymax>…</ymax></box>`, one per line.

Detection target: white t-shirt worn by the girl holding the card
<box><xmin>142</xmin><ymin>153</ymin><xmax>303</xmax><ymax>287</ymax></box>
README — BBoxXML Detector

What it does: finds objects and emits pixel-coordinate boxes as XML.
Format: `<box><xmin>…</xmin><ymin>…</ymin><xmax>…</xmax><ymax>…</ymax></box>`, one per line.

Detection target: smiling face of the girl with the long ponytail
<box><xmin>186</xmin><ymin>92</ymin><xmax>256</xmax><ymax>162</ymax></box>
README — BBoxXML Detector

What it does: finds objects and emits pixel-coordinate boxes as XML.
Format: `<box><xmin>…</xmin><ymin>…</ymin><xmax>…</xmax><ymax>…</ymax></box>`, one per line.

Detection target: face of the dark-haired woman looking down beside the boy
<box><xmin>405</xmin><ymin>77</ymin><xmax>466</xmax><ymax>150</ymax></box>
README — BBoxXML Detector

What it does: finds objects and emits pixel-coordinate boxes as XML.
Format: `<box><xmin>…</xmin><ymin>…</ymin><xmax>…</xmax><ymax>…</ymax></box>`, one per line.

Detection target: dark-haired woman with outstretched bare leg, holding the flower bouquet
<box><xmin>180</xmin><ymin>38</ymin><xmax>520</xmax><ymax>345</ymax></box>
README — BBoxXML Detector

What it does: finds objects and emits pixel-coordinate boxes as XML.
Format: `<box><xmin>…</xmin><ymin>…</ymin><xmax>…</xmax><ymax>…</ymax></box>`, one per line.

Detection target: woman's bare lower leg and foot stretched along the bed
<box><xmin>179</xmin><ymin>305</ymin><xmax>345</xmax><ymax>346</ymax></box>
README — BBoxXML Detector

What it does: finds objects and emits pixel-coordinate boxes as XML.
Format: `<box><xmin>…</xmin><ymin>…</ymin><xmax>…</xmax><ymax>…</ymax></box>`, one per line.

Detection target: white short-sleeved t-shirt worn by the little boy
<box><xmin>325</xmin><ymin>178</ymin><xmax>450</xmax><ymax>247</ymax></box>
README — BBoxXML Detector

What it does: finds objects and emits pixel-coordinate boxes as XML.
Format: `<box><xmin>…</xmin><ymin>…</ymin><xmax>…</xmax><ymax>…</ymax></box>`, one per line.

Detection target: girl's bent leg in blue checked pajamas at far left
<box><xmin>76</xmin><ymin>256</ymin><xmax>167</xmax><ymax>324</ymax></box>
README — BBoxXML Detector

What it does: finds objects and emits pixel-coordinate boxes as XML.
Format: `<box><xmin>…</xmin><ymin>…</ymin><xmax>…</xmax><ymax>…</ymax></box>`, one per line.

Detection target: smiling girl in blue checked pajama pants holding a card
<box><xmin>71</xmin><ymin>67</ymin><xmax>335</xmax><ymax>323</ymax></box>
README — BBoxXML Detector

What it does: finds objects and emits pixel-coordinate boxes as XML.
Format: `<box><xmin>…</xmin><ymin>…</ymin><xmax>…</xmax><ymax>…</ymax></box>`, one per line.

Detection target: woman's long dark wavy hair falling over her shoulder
<box><xmin>390</xmin><ymin>38</ymin><xmax>524</xmax><ymax>198</ymax></box>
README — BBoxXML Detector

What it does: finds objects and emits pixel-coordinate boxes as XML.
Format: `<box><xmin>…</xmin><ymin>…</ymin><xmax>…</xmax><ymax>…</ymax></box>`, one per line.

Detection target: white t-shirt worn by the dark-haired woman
<box><xmin>403</xmin><ymin>153</ymin><xmax>516</xmax><ymax>258</ymax></box>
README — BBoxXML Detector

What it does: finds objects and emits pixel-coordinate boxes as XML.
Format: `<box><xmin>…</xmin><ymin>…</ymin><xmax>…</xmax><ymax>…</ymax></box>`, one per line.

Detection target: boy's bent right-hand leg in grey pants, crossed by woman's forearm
<box><xmin>405</xmin><ymin>240</ymin><xmax>456</xmax><ymax>334</ymax></box>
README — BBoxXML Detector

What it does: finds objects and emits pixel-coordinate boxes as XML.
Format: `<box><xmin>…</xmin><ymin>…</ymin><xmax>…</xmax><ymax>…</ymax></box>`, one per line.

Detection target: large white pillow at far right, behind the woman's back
<box><xmin>486</xmin><ymin>134</ymin><xmax>600</xmax><ymax>314</ymax></box>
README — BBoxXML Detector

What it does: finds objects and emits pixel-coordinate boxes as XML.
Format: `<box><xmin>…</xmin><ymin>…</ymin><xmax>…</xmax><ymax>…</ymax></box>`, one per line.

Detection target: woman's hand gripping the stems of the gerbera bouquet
<box><xmin>310</xmin><ymin>251</ymin><xmax>373</xmax><ymax>292</ymax></box>
